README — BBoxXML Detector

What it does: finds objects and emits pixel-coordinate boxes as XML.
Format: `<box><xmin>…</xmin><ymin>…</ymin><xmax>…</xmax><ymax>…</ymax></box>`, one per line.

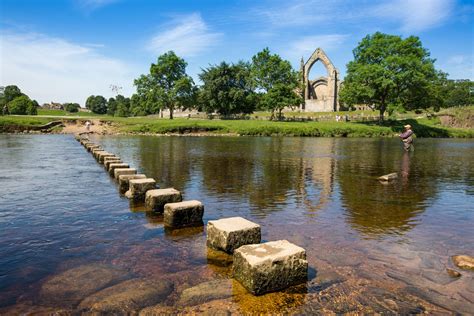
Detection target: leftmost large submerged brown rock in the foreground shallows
<box><xmin>39</xmin><ymin>264</ymin><xmax>129</xmax><ymax>307</ymax></box>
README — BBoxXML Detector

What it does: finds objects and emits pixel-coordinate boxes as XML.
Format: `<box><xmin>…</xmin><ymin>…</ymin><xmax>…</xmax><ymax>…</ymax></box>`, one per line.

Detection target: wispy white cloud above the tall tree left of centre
<box><xmin>148</xmin><ymin>13</ymin><xmax>222</xmax><ymax>57</ymax></box>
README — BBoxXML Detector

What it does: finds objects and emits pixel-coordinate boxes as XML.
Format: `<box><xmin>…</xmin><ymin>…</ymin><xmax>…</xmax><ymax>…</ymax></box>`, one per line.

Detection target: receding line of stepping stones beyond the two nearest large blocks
<box><xmin>76</xmin><ymin>137</ymin><xmax>204</xmax><ymax>228</ymax></box>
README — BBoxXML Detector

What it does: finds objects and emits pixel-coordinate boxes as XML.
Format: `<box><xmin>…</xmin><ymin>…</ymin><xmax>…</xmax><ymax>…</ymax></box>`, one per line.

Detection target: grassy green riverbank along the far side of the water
<box><xmin>0</xmin><ymin>110</ymin><xmax>474</xmax><ymax>138</ymax></box>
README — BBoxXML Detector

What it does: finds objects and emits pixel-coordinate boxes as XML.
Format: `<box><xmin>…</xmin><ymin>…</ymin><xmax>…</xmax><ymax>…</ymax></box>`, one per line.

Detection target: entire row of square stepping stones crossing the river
<box><xmin>78</xmin><ymin>139</ymin><xmax>308</xmax><ymax>295</ymax></box>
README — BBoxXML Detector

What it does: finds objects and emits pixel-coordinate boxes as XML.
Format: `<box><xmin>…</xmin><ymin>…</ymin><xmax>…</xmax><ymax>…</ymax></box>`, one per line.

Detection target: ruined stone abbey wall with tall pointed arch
<box><xmin>301</xmin><ymin>48</ymin><xmax>339</xmax><ymax>112</ymax></box>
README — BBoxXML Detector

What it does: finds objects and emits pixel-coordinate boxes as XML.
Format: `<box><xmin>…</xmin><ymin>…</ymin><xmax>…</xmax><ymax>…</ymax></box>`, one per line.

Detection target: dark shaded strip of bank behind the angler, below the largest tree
<box><xmin>355</xmin><ymin>119</ymin><xmax>453</xmax><ymax>138</ymax></box>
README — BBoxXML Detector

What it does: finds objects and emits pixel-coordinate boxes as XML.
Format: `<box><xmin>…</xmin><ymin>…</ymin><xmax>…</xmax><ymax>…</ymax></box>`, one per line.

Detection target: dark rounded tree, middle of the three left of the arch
<box><xmin>199</xmin><ymin>62</ymin><xmax>255</xmax><ymax>116</ymax></box>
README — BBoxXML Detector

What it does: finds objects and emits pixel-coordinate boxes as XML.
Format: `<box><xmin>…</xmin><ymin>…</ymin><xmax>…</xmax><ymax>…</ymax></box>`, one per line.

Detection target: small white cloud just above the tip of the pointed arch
<box><xmin>288</xmin><ymin>34</ymin><xmax>348</xmax><ymax>60</ymax></box>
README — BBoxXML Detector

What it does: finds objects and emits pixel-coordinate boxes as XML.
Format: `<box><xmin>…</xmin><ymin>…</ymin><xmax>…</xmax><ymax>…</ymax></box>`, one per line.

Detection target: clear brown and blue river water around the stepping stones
<box><xmin>0</xmin><ymin>135</ymin><xmax>474</xmax><ymax>314</ymax></box>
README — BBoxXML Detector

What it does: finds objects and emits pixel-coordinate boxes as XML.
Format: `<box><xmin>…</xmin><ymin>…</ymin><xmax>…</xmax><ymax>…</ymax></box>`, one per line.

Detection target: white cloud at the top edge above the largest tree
<box><xmin>371</xmin><ymin>0</ymin><xmax>455</xmax><ymax>32</ymax></box>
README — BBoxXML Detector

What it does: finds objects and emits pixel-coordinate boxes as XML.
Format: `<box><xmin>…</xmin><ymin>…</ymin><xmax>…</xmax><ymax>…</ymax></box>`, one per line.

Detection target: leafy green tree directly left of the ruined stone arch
<box><xmin>251</xmin><ymin>48</ymin><xmax>303</xmax><ymax>119</ymax></box>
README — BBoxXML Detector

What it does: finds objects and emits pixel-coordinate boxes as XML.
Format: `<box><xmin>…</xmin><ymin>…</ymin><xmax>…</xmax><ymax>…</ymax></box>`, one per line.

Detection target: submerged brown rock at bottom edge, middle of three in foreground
<box><xmin>79</xmin><ymin>279</ymin><xmax>173</xmax><ymax>313</ymax></box>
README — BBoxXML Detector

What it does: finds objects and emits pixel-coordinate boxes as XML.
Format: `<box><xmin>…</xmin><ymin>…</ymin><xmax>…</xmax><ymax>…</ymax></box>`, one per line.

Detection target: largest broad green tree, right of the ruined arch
<box><xmin>339</xmin><ymin>32</ymin><xmax>438</xmax><ymax>121</ymax></box>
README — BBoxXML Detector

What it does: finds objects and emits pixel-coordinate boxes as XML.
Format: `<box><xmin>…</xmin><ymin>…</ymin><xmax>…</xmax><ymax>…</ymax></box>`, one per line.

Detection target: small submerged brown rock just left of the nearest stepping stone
<box><xmin>177</xmin><ymin>279</ymin><xmax>232</xmax><ymax>306</ymax></box>
